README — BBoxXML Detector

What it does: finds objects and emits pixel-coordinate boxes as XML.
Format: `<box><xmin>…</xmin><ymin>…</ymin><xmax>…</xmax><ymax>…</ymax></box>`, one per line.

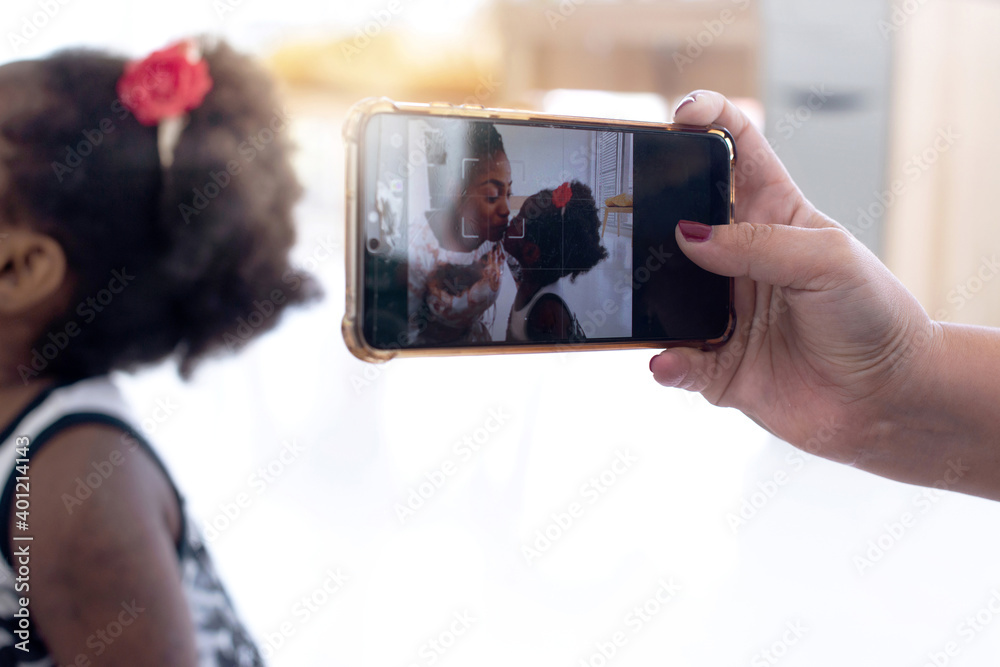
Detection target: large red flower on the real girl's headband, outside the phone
<box><xmin>117</xmin><ymin>41</ymin><xmax>212</xmax><ymax>126</ymax></box>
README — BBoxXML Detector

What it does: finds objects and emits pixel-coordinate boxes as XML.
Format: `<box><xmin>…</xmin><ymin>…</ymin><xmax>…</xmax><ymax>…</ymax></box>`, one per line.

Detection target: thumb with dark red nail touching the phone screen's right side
<box><xmin>676</xmin><ymin>220</ymin><xmax>857</xmax><ymax>289</ymax></box>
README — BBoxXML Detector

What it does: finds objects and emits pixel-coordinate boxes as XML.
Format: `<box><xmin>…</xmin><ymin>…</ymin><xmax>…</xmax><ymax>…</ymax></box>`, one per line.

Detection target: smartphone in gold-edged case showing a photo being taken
<box><xmin>343</xmin><ymin>99</ymin><xmax>736</xmax><ymax>361</ymax></box>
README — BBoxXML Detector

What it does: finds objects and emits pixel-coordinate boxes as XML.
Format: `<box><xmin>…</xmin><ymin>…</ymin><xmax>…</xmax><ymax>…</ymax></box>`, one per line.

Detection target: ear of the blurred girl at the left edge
<box><xmin>0</xmin><ymin>229</ymin><xmax>66</xmax><ymax>315</ymax></box>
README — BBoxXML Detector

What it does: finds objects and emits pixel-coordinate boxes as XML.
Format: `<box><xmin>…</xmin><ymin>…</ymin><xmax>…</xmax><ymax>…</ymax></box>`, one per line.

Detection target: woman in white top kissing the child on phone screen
<box><xmin>408</xmin><ymin>121</ymin><xmax>511</xmax><ymax>345</ymax></box>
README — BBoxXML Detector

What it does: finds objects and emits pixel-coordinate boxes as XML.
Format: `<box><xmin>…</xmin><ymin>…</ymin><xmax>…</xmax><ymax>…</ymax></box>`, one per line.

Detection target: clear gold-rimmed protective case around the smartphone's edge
<box><xmin>341</xmin><ymin>97</ymin><xmax>736</xmax><ymax>362</ymax></box>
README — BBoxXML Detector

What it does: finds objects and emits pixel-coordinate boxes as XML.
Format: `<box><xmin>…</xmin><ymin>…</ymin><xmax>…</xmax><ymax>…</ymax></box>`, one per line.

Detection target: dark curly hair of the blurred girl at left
<box><xmin>0</xmin><ymin>43</ymin><xmax>319</xmax><ymax>379</ymax></box>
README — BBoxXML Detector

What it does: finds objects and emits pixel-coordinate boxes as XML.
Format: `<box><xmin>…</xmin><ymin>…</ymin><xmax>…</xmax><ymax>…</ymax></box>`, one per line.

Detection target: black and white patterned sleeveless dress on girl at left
<box><xmin>0</xmin><ymin>377</ymin><xmax>264</xmax><ymax>667</ymax></box>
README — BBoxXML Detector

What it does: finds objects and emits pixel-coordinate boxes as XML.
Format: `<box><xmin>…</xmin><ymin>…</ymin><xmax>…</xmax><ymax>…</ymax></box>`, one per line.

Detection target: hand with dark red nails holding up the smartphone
<box><xmin>650</xmin><ymin>91</ymin><xmax>943</xmax><ymax>484</ymax></box>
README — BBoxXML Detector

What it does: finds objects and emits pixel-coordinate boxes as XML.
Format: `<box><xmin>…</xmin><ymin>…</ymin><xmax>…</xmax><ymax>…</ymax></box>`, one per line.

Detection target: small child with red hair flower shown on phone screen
<box><xmin>503</xmin><ymin>181</ymin><xmax>608</xmax><ymax>343</ymax></box>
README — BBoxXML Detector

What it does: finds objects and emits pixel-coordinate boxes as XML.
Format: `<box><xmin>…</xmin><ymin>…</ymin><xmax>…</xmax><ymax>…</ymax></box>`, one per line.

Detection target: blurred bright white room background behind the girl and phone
<box><xmin>0</xmin><ymin>0</ymin><xmax>1000</xmax><ymax>667</ymax></box>
